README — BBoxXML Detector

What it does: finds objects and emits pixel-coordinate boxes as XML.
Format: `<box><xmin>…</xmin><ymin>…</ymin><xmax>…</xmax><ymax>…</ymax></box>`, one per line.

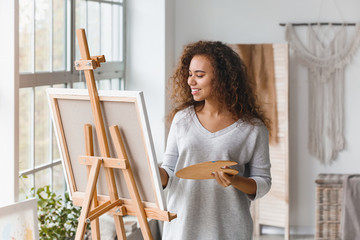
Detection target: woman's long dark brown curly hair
<box><xmin>168</xmin><ymin>41</ymin><xmax>270</xmax><ymax>127</ymax></box>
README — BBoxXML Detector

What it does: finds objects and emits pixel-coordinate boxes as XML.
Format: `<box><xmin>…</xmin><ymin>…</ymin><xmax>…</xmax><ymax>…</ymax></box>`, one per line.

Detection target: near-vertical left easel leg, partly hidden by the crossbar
<box><xmin>84</xmin><ymin>124</ymin><xmax>100</xmax><ymax>239</ymax></box>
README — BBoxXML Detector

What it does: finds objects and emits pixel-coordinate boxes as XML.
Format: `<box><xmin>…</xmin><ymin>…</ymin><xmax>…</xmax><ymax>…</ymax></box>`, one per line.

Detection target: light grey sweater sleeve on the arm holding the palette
<box><xmin>249</xmin><ymin>126</ymin><xmax>271</xmax><ymax>200</ymax></box>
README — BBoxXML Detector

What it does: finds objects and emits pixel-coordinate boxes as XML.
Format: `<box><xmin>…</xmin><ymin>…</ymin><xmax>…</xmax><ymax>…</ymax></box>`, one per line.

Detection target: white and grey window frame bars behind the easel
<box><xmin>16</xmin><ymin>0</ymin><xmax>126</xmax><ymax>200</ymax></box>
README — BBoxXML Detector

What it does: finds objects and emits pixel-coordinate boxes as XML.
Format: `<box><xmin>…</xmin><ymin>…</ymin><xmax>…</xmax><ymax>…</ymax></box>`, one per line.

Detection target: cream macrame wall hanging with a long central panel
<box><xmin>285</xmin><ymin>23</ymin><xmax>360</xmax><ymax>165</ymax></box>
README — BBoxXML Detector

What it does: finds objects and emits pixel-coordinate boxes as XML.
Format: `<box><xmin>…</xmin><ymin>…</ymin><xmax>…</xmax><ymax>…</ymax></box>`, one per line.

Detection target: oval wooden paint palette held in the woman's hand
<box><xmin>175</xmin><ymin>160</ymin><xmax>239</xmax><ymax>179</ymax></box>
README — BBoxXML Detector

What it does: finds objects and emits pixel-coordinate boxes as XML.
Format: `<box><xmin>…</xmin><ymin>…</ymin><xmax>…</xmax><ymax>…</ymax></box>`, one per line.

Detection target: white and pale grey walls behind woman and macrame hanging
<box><xmin>127</xmin><ymin>0</ymin><xmax>360</xmax><ymax>231</ymax></box>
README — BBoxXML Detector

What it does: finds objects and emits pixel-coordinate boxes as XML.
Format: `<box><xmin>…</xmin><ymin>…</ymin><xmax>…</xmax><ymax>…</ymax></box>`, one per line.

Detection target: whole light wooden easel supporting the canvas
<box><xmin>75</xmin><ymin>29</ymin><xmax>176</xmax><ymax>240</ymax></box>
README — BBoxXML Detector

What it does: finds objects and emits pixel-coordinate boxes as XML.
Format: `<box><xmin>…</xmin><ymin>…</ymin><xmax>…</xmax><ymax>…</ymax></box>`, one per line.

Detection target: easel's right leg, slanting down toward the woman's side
<box><xmin>110</xmin><ymin>126</ymin><xmax>153</xmax><ymax>240</ymax></box>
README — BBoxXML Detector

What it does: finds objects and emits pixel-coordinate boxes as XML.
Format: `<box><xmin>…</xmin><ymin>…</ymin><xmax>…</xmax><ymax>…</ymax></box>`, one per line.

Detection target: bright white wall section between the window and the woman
<box><xmin>126</xmin><ymin>0</ymin><xmax>166</xmax><ymax>161</ymax></box>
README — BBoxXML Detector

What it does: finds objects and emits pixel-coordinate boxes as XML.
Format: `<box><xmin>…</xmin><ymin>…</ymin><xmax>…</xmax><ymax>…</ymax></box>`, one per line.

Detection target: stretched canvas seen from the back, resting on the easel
<box><xmin>47</xmin><ymin>88</ymin><xmax>166</xmax><ymax>211</ymax></box>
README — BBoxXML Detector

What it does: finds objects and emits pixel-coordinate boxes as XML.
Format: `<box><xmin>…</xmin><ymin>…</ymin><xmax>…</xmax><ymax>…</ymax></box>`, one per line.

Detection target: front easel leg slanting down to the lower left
<box><xmin>75</xmin><ymin>160</ymin><xmax>102</xmax><ymax>240</ymax></box>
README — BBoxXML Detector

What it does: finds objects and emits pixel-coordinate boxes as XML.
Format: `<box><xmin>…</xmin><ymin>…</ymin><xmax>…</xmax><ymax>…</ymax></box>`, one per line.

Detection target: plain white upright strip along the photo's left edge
<box><xmin>0</xmin><ymin>1</ymin><xmax>19</xmax><ymax>206</ymax></box>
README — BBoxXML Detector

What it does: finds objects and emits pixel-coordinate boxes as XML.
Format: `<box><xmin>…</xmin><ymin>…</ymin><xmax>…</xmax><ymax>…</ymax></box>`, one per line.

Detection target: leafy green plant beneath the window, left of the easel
<box><xmin>36</xmin><ymin>186</ymin><xmax>81</xmax><ymax>239</ymax></box>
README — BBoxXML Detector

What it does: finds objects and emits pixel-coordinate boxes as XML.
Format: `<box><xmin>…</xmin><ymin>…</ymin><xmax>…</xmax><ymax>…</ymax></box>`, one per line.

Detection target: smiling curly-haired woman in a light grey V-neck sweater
<box><xmin>160</xmin><ymin>41</ymin><xmax>271</xmax><ymax>240</ymax></box>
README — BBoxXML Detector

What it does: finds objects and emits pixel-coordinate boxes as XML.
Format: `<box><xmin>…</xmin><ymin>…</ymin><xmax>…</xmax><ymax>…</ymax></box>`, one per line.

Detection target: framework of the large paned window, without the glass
<box><xmin>14</xmin><ymin>0</ymin><xmax>126</xmax><ymax>198</ymax></box>
